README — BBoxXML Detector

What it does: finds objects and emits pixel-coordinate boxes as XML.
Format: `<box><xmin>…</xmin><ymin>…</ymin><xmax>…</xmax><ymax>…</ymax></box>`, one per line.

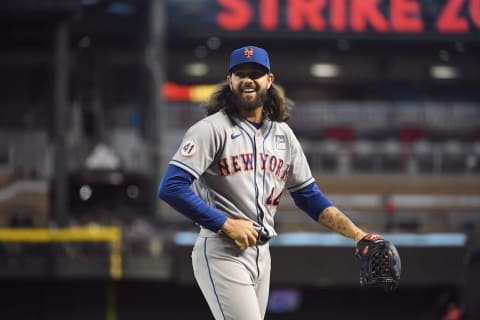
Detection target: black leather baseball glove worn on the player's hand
<box><xmin>355</xmin><ymin>234</ymin><xmax>402</xmax><ymax>291</ymax></box>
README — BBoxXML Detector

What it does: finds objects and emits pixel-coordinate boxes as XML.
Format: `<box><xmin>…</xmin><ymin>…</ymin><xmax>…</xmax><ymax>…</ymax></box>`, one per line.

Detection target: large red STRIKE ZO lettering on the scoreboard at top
<box><xmin>216</xmin><ymin>0</ymin><xmax>480</xmax><ymax>33</ymax></box>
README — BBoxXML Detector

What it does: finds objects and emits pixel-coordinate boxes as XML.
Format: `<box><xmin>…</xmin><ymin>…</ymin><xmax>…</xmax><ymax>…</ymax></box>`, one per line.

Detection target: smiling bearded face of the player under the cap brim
<box><xmin>227</xmin><ymin>63</ymin><xmax>273</xmax><ymax>116</ymax></box>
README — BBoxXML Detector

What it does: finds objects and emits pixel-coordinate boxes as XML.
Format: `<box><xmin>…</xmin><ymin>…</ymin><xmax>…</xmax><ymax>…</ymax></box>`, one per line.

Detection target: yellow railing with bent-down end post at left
<box><xmin>0</xmin><ymin>226</ymin><xmax>122</xmax><ymax>280</ymax></box>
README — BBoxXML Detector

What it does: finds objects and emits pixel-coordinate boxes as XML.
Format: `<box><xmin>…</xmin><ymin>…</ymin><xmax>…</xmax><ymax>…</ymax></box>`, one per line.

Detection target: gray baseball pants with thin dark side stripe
<box><xmin>192</xmin><ymin>228</ymin><xmax>271</xmax><ymax>320</ymax></box>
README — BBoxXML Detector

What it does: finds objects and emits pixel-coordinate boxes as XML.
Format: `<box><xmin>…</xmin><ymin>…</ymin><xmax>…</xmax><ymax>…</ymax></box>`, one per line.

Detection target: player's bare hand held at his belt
<box><xmin>222</xmin><ymin>218</ymin><xmax>258</xmax><ymax>250</ymax></box>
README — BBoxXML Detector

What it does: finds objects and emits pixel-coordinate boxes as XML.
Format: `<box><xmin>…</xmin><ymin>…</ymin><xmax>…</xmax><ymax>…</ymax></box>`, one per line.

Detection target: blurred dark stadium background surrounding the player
<box><xmin>0</xmin><ymin>0</ymin><xmax>480</xmax><ymax>320</ymax></box>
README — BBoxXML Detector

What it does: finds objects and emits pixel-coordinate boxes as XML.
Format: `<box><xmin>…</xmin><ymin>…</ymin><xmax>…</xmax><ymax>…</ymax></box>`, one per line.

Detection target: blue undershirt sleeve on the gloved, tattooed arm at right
<box><xmin>291</xmin><ymin>182</ymin><xmax>333</xmax><ymax>221</ymax></box>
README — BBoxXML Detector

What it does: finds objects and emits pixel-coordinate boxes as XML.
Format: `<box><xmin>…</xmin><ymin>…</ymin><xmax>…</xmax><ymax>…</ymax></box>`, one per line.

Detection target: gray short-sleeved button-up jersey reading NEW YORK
<box><xmin>170</xmin><ymin>111</ymin><xmax>314</xmax><ymax>235</ymax></box>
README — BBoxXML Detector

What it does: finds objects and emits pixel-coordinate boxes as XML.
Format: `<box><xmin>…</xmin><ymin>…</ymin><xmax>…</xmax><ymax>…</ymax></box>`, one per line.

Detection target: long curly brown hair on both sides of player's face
<box><xmin>202</xmin><ymin>82</ymin><xmax>293</xmax><ymax>122</ymax></box>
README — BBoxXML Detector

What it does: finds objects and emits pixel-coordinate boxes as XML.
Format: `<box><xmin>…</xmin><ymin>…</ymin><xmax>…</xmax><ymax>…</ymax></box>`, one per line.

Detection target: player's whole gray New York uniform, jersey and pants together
<box><xmin>170</xmin><ymin>111</ymin><xmax>314</xmax><ymax>320</ymax></box>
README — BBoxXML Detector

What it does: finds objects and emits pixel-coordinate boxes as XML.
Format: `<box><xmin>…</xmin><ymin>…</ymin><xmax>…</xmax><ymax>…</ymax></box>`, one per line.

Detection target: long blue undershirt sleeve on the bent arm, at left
<box><xmin>158</xmin><ymin>164</ymin><xmax>227</xmax><ymax>232</ymax></box>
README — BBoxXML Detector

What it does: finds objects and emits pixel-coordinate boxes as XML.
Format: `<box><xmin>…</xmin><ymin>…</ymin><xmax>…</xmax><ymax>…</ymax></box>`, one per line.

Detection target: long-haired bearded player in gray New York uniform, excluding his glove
<box><xmin>158</xmin><ymin>46</ymin><xmax>374</xmax><ymax>320</ymax></box>
